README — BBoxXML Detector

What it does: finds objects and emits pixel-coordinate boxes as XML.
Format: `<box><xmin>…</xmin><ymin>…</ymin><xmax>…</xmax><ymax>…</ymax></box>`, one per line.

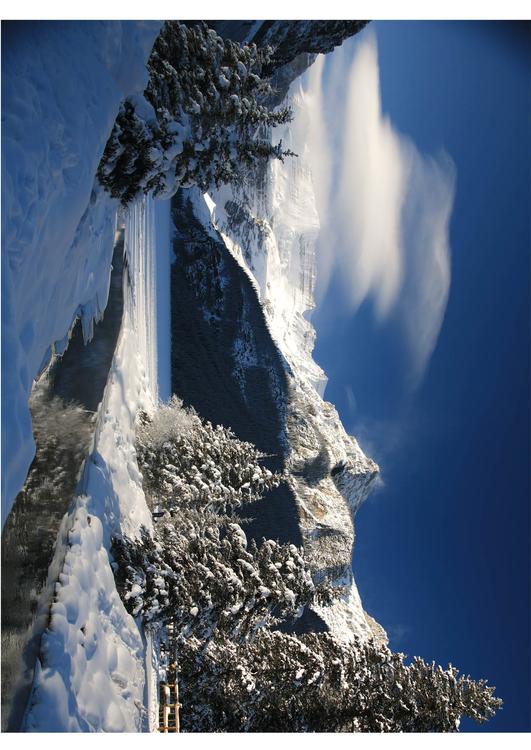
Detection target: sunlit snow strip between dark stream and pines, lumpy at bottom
<box><xmin>25</xmin><ymin>197</ymin><xmax>169</xmax><ymax>732</ymax></box>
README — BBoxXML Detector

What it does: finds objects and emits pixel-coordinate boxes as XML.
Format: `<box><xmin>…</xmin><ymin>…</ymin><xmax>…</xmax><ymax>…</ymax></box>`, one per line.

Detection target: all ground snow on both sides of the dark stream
<box><xmin>2</xmin><ymin>22</ymin><xmax>179</xmax><ymax>732</ymax></box>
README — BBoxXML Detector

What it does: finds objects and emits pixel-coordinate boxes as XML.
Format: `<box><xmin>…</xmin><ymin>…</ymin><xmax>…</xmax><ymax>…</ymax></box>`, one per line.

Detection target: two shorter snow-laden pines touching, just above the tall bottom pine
<box><xmin>112</xmin><ymin>397</ymin><xmax>330</xmax><ymax>641</ymax></box>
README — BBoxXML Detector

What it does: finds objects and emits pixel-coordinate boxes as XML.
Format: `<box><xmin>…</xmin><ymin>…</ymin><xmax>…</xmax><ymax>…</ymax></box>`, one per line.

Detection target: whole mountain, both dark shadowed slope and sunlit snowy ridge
<box><xmin>172</xmin><ymin>78</ymin><xmax>386</xmax><ymax>641</ymax></box>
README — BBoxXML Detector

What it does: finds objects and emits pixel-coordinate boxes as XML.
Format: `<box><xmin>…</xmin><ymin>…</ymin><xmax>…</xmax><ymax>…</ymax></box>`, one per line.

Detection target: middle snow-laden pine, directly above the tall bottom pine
<box><xmin>112</xmin><ymin>510</ymin><xmax>316</xmax><ymax>642</ymax></box>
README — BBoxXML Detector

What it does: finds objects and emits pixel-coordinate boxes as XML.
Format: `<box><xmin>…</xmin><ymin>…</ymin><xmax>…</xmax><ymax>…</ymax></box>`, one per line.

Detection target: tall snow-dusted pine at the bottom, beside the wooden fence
<box><xmin>179</xmin><ymin>630</ymin><xmax>501</xmax><ymax>732</ymax></box>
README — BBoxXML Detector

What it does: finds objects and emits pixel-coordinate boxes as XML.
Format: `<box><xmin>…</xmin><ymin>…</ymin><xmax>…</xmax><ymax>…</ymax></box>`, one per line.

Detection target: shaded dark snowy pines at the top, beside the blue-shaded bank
<box><xmin>98</xmin><ymin>21</ymin><xmax>292</xmax><ymax>204</ymax></box>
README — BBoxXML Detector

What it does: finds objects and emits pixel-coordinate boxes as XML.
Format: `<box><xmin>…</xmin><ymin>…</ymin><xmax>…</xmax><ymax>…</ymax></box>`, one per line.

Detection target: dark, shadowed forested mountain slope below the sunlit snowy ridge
<box><xmin>171</xmin><ymin>188</ymin><xmax>302</xmax><ymax>545</ymax></box>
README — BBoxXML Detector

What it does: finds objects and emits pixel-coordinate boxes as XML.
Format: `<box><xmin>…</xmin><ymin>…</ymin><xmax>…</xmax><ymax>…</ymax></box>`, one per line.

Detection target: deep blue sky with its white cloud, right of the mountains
<box><xmin>305</xmin><ymin>22</ymin><xmax>531</xmax><ymax>731</ymax></box>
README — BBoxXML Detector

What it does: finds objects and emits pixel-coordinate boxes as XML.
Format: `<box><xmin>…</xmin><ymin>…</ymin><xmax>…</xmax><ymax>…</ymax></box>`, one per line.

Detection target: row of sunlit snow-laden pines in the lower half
<box><xmin>112</xmin><ymin>398</ymin><xmax>501</xmax><ymax>732</ymax></box>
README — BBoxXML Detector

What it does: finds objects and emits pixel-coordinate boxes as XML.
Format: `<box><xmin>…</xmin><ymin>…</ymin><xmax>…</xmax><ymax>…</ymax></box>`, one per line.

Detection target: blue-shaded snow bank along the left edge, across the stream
<box><xmin>2</xmin><ymin>21</ymin><xmax>161</xmax><ymax>524</ymax></box>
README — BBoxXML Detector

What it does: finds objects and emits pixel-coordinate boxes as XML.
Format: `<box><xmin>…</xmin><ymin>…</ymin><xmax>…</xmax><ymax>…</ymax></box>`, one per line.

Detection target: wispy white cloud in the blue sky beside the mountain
<box><xmin>295</xmin><ymin>33</ymin><xmax>456</xmax><ymax>388</ymax></box>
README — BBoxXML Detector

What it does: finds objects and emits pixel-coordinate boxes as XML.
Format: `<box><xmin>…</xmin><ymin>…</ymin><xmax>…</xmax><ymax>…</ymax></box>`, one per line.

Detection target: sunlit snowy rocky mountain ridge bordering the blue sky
<box><xmin>206</xmin><ymin>83</ymin><xmax>385</xmax><ymax>639</ymax></box>
